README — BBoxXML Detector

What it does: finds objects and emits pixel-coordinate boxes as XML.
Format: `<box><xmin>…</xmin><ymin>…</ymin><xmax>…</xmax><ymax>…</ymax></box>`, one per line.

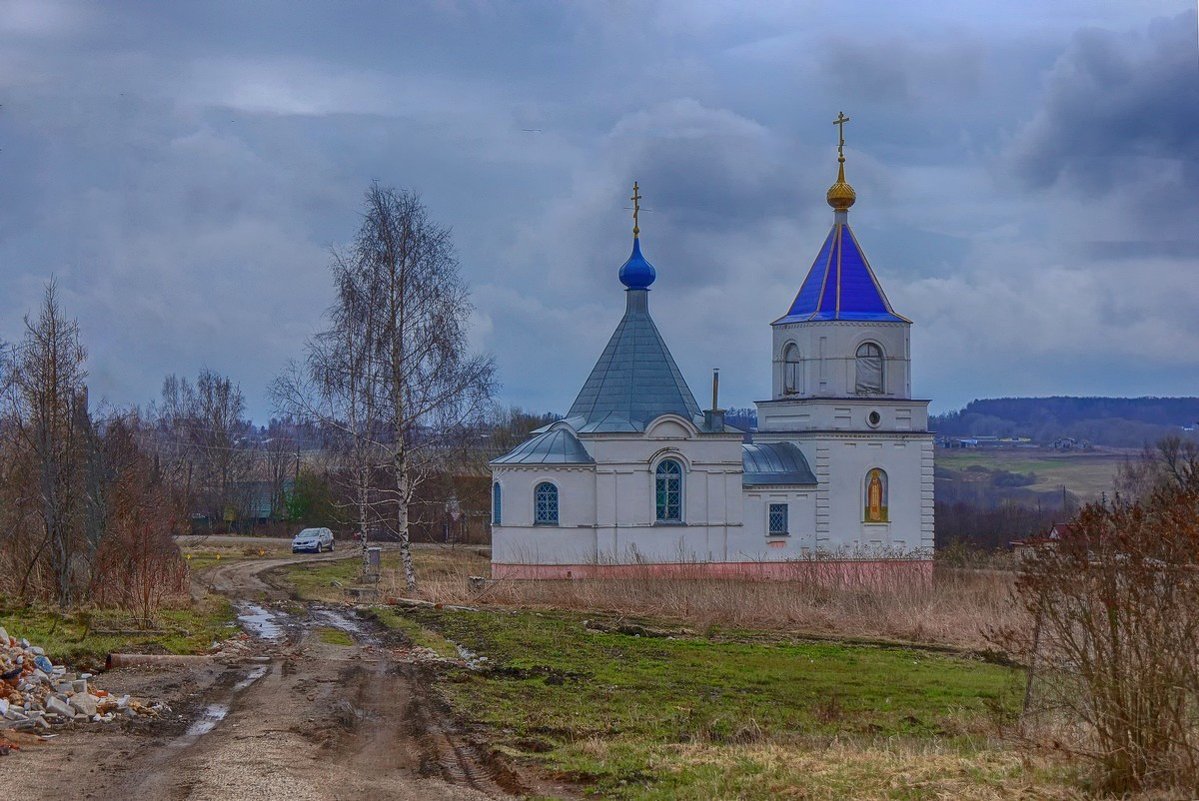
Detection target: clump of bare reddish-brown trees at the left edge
<box><xmin>0</xmin><ymin>282</ymin><xmax>186</xmax><ymax>616</ymax></box>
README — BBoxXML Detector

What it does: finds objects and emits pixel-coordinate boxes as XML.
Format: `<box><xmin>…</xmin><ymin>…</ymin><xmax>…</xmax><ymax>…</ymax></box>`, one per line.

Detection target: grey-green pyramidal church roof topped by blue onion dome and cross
<box><xmin>566</xmin><ymin>183</ymin><xmax>701</xmax><ymax>434</ymax></box>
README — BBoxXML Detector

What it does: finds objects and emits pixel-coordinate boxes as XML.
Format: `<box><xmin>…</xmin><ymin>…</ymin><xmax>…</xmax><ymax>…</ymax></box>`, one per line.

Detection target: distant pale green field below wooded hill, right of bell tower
<box><xmin>936</xmin><ymin>450</ymin><xmax>1125</xmax><ymax>500</ymax></box>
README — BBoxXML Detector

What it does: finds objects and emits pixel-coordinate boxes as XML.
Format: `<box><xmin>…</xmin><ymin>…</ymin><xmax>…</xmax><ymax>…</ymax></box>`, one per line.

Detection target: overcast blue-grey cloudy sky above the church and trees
<box><xmin>0</xmin><ymin>0</ymin><xmax>1199</xmax><ymax>422</ymax></box>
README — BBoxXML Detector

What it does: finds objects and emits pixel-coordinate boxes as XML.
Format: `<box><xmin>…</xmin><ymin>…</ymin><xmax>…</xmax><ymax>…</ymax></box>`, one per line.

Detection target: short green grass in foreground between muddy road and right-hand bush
<box><xmin>392</xmin><ymin>609</ymin><xmax>1072</xmax><ymax>800</ymax></box>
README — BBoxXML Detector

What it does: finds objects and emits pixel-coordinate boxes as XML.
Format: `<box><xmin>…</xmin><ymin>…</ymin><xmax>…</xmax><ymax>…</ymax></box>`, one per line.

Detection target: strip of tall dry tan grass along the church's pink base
<box><xmin>380</xmin><ymin>547</ymin><xmax>1025</xmax><ymax>649</ymax></box>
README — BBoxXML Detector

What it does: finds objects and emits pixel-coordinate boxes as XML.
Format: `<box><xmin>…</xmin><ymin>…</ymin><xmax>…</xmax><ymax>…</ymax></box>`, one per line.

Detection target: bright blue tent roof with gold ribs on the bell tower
<box><xmin>775</xmin><ymin>222</ymin><xmax>909</xmax><ymax>323</ymax></box>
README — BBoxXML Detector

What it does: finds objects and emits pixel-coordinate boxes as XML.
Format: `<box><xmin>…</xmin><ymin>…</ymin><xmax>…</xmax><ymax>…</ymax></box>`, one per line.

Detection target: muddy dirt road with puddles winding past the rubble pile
<box><xmin>7</xmin><ymin>554</ymin><xmax>547</xmax><ymax>801</ymax></box>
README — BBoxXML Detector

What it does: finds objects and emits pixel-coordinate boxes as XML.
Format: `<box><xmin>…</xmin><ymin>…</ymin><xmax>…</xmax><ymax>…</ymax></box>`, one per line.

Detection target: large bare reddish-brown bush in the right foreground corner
<box><xmin>996</xmin><ymin>463</ymin><xmax>1199</xmax><ymax>793</ymax></box>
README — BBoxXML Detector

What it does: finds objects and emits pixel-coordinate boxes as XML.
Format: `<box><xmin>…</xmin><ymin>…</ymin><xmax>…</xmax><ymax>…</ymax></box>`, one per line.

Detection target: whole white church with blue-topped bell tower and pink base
<box><xmin>490</xmin><ymin>131</ymin><xmax>933</xmax><ymax>579</ymax></box>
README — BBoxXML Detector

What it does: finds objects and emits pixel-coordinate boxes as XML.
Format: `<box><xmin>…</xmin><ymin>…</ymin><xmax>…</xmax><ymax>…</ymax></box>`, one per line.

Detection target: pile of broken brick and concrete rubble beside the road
<box><xmin>0</xmin><ymin>627</ymin><xmax>163</xmax><ymax>731</ymax></box>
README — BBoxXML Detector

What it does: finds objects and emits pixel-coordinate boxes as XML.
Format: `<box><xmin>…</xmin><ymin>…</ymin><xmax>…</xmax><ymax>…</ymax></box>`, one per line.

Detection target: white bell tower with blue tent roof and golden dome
<box><xmin>754</xmin><ymin>114</ymin><xmax>933</xmax><ymax>555</ymax></box>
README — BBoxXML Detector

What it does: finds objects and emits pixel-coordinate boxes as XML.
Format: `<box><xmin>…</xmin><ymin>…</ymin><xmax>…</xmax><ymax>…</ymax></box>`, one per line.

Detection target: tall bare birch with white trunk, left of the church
<box><xmin>277</xmin><ymin>185</ymin><xmax>495</xmax><ymax>591</ymax></box>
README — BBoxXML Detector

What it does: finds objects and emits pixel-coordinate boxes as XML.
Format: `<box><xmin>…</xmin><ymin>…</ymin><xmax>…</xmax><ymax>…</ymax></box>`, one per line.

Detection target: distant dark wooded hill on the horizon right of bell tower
<box><xmin>929</xmin><ymin>397</ymin><xmax>1199</xmax><ymax>447</ymax></box>
